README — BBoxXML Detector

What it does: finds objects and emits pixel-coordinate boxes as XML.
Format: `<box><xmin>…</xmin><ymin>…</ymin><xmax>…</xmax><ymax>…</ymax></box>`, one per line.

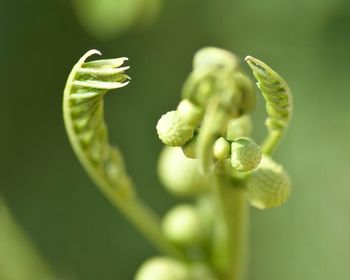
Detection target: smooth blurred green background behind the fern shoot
<box><xmin>0</xmin><ymin>0</ymin><xmax>350</xmax><ymax>280</ymax></box>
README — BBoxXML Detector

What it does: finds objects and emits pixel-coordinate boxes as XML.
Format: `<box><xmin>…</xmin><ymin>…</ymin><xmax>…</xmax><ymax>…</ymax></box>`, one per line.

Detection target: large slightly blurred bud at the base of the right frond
<box><xmin>247</xmin><ymin>156</ymin><xmax>292</xmax><ymax>209</ymax></box>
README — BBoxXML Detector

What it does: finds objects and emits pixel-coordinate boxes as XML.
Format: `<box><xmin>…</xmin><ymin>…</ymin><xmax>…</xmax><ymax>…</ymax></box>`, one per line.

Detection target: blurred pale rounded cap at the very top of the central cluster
<box><xmin>193</xmin><ymin>47</ymin><xmax>239</xmax><ymax>68</ymax></box>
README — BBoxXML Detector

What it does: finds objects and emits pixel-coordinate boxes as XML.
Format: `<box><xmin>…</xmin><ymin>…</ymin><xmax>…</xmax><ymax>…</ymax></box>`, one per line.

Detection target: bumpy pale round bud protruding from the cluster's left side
<box><xmin>157</xmin><ymin>111</ymin><xmax>194</xmax><ymax>147</ymax></box>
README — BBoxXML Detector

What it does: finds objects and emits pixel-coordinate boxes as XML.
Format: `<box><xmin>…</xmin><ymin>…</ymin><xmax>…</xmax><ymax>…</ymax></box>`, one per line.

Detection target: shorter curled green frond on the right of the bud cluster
<box><xmin>245</xmin><ymin>56</ymin><xmax>292</xmax><ymax>154</ymax></box>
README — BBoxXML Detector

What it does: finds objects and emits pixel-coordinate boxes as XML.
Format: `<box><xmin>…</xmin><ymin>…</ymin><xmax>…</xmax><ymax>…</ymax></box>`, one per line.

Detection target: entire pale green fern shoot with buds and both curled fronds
<box><xmin>63</xmin><ymin>47</ymin><xmax>292</xmax><ymax>280</ymax></box>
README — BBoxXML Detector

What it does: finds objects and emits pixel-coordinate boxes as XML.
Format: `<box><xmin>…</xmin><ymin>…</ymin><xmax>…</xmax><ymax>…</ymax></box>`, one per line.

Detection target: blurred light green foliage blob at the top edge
<box><xmin>73</xmin><ymin>0</ymin><xmax>161</xmax><ymax>39</ymax></box>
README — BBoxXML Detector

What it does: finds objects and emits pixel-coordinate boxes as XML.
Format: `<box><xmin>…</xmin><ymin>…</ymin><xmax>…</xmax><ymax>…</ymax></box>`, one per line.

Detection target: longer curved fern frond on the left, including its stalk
<box><xmin>63</xmin><ymin>50</ymin><xmax>180</xmax><ymax>256</ymax></box>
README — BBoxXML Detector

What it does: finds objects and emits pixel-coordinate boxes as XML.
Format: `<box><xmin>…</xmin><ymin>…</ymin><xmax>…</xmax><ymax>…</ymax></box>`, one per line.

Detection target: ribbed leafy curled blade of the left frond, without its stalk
<box><xmin>63</xmin><ymin>50</ymin><xmax>129</xmax><ymax>196</ymax></box>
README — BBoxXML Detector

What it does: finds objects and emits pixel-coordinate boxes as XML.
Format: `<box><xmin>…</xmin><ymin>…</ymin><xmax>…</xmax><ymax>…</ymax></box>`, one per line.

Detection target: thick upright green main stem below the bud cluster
<box><xmin>213</xmin><ymin>168</ymin><xmax>249</xmax><ymax>280</ymax></box>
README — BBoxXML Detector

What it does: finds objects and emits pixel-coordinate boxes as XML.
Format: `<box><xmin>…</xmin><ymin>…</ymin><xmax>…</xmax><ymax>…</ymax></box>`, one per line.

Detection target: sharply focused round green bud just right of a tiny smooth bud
<box><xmin>231</xmin><ymin>138</ymin><xmax>262</xmax><ymax>172</ymax></box>
